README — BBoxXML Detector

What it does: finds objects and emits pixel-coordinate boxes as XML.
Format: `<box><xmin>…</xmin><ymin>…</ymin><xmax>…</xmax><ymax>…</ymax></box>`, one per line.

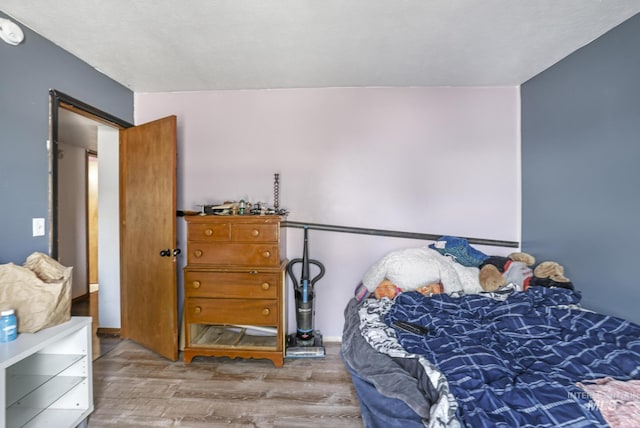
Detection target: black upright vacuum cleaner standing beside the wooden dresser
<box><xmin>285</xmin><ymin>226</ymin><xmax>325</xmax><ymax>358</ymax></box>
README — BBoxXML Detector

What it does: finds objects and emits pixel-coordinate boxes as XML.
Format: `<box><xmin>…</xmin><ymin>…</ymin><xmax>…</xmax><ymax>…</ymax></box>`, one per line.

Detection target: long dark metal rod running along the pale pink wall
<box><xmin>281</xmin><ymin>221</ymin><xmax>520</xmax><ymax>248</ymax></box>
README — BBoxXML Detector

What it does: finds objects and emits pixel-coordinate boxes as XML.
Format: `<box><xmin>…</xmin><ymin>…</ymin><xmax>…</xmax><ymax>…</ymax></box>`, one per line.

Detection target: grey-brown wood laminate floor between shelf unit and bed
<box><xmin>74</xmin><ymin>294</ymin><xmax>363</xmax><ymax>428</ymax></box>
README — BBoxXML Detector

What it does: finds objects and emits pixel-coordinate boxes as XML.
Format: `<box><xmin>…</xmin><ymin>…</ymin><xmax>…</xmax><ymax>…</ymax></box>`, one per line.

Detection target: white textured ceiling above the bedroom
<box><xmin>0</xmin><ymin>0</ymin><xmax>640</xmax><ymax>92</ymax></box>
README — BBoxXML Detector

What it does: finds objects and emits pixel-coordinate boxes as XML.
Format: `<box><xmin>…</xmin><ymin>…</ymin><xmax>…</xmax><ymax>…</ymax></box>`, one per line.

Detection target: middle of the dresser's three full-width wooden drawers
<box><xmin>184</xmin><ymin>270</ymin><xmax>280</xmax><ymax>299</ymax></box>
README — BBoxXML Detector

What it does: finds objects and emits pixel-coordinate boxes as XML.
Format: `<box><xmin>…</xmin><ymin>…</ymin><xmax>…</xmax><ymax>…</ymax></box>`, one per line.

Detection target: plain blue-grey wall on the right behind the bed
<box><xmin>521</xmin><ymin>11</ymin><xmax>640</xmax><ymax>322</ymax></box>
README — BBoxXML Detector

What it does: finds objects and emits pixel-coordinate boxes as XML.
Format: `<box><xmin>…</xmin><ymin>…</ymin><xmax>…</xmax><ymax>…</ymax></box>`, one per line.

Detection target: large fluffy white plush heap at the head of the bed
<box><xmin>362</xmin><ymin>246</ymin><xmax>483</xmax><ymax>294</ymax></box>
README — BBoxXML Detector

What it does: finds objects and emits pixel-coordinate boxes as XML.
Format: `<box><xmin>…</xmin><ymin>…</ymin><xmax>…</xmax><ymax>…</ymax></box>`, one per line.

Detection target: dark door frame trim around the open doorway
<box><xmin>49</xmin><ymin>89</ymin><xmax>133</xmax><ymax>260</ymax></box>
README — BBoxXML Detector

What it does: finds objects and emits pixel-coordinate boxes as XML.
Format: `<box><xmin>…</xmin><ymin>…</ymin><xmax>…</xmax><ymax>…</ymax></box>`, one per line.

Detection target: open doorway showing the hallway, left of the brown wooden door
<box><xmin>49</xmin><ymin>90</ymin><xmax>132</xmax><ymax>333</ymax></box>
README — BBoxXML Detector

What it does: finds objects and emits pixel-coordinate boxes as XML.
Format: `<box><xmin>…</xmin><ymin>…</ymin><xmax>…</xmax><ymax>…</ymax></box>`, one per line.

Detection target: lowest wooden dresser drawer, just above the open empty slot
<box><xmin>185</xmin><ymin>298</ymin><xmax>279</xmax><ymax>326</ymax></box>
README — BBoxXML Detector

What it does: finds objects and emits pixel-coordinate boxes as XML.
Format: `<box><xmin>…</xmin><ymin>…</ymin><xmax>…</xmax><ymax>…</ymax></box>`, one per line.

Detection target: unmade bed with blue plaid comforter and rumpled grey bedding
<box><xmin>341</xmin><ymin>239</ymin><xmax>640</xmax><ymax>428</ymax></box>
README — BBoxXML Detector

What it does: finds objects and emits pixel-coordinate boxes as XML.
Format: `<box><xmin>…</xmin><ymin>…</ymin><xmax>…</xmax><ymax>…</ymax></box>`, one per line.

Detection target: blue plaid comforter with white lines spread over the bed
<box><xmin>385</xmin><ymin>287</ymin><xmax>640</xmax><ymax>428</ymax></box>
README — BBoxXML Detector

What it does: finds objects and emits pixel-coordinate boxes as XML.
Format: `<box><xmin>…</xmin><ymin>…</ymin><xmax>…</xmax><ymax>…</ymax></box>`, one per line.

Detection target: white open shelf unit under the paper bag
<box><xmin>0</xmin><ymin>317</ymin><xmax>93</xmax><ymax>428</ymax></box>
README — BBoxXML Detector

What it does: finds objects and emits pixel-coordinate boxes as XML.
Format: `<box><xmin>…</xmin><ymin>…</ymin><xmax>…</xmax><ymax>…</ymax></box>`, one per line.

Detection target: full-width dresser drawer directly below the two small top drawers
<box><xmin>187</xmin><ymin>242</ymin><xmax>280</xmax><ymax>267</ymax></box>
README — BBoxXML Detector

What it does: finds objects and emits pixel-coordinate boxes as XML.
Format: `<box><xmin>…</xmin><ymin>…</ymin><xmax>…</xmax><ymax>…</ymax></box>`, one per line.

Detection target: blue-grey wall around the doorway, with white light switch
<box><xmin>0</xmin><ymin>12</ymin><xmax>133</xmax><ymax>264</ymax></box>
